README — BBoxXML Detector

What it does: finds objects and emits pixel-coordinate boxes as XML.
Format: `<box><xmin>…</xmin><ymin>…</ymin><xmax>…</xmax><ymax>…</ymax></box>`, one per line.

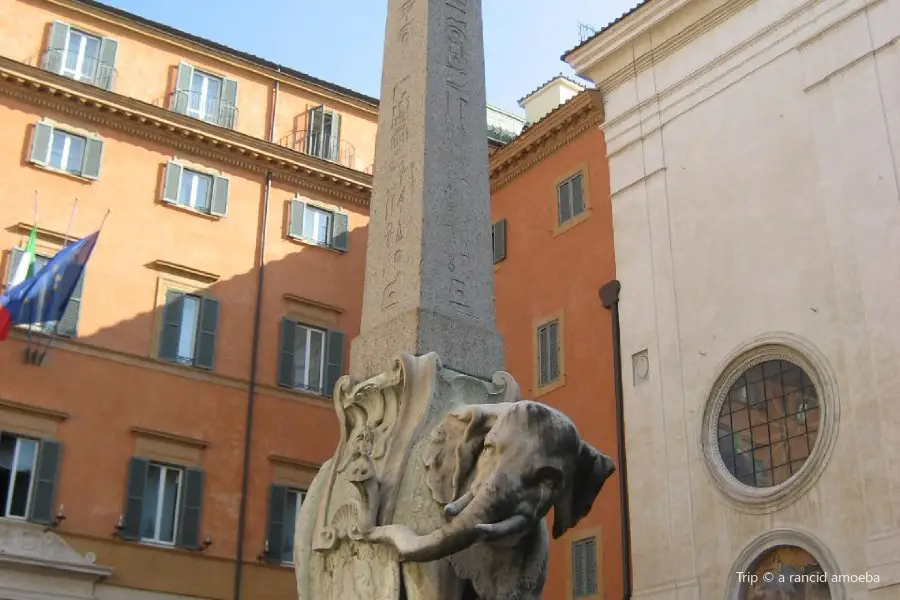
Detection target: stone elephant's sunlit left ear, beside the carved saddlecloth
<box><xmin>424</xmin><ymin>406</ymin><xmax>488</xmax><ymax>504</ymax></box>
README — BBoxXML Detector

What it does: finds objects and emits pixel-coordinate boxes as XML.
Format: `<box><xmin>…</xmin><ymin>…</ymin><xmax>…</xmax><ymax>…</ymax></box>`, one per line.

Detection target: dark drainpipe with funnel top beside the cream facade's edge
<box><xmin>600</xmin><ymin>279</ymin><xmax>632</xmax><ymax>600</ymax></box>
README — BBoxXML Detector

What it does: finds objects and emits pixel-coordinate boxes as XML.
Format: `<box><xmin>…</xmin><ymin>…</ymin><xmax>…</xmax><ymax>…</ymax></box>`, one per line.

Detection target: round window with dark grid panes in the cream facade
<box><xmin>718</xmin><ymin>360</ymin><xmax>820</xmax><ymax>488</ymax></box>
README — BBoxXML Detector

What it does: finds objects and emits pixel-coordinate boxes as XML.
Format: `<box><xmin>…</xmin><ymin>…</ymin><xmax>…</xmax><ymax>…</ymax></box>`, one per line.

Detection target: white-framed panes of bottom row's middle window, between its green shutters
<box><xmin>141</xmin><ymin>463</ymin><xmax>182</xmax><ymax>544</ymax></box>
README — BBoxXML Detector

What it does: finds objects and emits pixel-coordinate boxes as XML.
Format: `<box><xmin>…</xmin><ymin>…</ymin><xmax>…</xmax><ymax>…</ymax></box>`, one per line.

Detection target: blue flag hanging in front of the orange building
<box><xmin>0</xmin><ymin>231</ymin><xmax>100</xmax><ymax>341</ymax></box>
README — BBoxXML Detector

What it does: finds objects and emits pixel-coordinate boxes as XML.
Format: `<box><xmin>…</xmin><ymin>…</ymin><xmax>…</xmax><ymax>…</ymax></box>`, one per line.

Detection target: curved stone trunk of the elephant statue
<box><xmin>366</xmin><ymin>492</ymin><xmax>496</xmax><ymax>562</ymax></box>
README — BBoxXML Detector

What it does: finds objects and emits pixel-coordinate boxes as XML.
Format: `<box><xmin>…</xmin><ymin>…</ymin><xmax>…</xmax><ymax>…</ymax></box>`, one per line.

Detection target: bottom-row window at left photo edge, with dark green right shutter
<box><xmin>0</xmin><ymin>432</ymin><xmax>61</xmax><ymax>524</ymax></box>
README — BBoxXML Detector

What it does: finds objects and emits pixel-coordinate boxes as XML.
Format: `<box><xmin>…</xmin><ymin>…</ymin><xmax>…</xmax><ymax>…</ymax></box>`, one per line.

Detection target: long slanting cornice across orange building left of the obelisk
<box><xmin>0</xmin><ymin>56</ymin><xmax>372</xmax><ymax>207</ymax></box>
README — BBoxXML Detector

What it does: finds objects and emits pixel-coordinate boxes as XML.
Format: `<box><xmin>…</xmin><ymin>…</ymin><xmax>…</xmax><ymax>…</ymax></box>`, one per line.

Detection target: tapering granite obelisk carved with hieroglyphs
<box><xmin>350</xmin><ymin>0</ymin><xmax>504</xmax><ymax>380</ymax></box>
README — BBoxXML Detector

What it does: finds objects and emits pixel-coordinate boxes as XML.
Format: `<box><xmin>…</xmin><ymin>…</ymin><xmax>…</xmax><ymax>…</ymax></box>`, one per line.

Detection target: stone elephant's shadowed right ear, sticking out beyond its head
<box><xmin>553</xmin><ymin>441</ymin><xmax>616</xmax><ymax>539</ymax></box>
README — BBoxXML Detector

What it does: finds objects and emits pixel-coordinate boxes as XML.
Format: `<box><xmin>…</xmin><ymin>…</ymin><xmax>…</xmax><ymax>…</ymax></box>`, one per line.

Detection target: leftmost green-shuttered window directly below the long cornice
<box><xmin>31</xmin><ymin>121</ymin><xmax>103</xmax><ymax>179</ymax></box>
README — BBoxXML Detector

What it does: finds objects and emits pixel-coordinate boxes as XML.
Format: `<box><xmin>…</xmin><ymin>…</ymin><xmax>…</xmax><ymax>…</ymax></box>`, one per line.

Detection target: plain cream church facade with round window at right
<box><xmin>566</xmin><ymin>0</ymin><xmax>900</xmax><ymax>600</ymax></box>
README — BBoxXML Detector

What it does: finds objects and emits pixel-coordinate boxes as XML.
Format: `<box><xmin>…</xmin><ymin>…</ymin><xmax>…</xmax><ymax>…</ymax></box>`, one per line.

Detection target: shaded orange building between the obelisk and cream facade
<box><xmin>490</xmin><ymin>77</ymin><xmax>623</xmax><ymax>600</ymax></box>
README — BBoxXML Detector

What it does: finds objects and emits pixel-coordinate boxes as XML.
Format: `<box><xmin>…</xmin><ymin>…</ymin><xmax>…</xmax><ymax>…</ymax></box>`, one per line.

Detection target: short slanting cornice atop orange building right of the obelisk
<box><xmin>490</xmin><ymin>90</ymin><xmax>603</xmax><ymax>191</ymax></box>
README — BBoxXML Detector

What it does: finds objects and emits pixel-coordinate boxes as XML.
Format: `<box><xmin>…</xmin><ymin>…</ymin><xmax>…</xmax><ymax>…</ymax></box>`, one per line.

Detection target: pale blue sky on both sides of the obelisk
<box><xmin>101</xmin><ymin>0</ymin><xmax>637</xmax><ymax>114</ymax></box>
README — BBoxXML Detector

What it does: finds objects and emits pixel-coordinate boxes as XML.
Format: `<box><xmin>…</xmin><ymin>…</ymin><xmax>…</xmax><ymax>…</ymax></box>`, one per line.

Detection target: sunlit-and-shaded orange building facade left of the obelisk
<box><xmin>0</xmin><ymin>0</ymin><xmax>377</xmax><ymax>600</ymax></box>
